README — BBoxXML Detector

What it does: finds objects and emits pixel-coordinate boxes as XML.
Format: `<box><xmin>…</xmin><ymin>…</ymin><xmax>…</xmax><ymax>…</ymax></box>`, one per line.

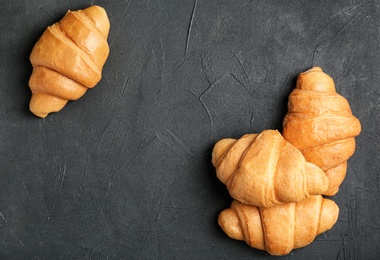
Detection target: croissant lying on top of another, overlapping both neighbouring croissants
<box><xmin>212</xmin><ymin>130</ymin><xmax>328</xmax><ymax>207</ymax></box>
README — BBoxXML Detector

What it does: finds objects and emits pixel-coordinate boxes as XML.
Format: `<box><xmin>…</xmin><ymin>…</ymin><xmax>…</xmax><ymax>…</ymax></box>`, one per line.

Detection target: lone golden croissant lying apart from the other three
<box><xmin>29</xmin><ymin>6</ymin><xmax>110</xmax><ymax>118</ymax></box>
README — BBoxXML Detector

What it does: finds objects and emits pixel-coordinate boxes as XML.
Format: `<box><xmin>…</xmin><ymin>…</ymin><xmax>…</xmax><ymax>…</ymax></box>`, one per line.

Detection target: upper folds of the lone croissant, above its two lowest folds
<box><xmin>30</xmin><ymin>6</ymin><xmax>110</xmax><ymax>87</ymax></box>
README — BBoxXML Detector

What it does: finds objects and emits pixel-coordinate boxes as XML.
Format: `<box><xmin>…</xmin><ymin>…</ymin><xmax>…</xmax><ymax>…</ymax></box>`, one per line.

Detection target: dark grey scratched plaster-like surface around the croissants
<box><xmin>0</xmin><ymin>0</ymin><xmax>380</xmax><ymax>259</ymax></box>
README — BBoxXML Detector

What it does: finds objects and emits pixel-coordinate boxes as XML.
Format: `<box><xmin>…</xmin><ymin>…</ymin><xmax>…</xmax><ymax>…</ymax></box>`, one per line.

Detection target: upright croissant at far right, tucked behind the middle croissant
<box><xmin>282</xmin><ymin>67</ymin><xmax>361</xmax><ymax>196</ymax></box>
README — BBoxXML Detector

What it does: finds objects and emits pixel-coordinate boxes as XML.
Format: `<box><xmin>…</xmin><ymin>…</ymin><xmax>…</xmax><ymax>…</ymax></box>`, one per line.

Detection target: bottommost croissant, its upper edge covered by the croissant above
<box><xmin>218</xmin><ymin>195</ymin><xmax>339</xmax><ymax>255</ymax></box>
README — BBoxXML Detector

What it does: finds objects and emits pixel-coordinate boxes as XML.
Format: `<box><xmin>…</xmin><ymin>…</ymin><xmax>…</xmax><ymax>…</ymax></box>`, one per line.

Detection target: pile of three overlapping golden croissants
<box><xmin>212</xmin><ymin>67</ymin><xmax>361</xmax><ymax>255</ymax></box>
